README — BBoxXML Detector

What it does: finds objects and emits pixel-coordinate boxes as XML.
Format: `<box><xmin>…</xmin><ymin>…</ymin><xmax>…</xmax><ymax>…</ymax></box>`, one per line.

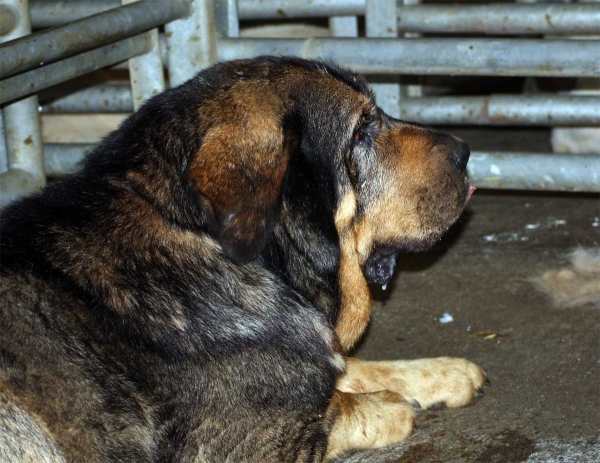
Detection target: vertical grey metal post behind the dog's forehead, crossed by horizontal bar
<box><xmin>365</xmin><ymin>0</ymin><xmax>400</xmax><ymax>117</ymax></box>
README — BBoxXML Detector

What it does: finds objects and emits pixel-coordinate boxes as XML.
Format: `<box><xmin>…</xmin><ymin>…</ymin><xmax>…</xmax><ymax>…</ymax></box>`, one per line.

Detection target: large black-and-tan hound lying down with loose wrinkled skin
<box><xmin>0</xmin><ymin>56</ymin><xmax>486</xmax><ymax>463</ymax></box>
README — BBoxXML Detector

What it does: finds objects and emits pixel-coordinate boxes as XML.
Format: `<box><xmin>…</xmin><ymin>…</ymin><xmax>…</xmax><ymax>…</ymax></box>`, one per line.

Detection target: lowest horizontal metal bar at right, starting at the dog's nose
<box><xmin>467</xmin><ymin>152</ymin><xmax>600</xmax><ymax>192</ymax></box>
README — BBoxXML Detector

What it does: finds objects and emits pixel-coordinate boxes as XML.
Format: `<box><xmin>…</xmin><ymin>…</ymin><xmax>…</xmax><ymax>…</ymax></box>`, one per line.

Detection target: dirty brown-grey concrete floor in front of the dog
<box><xmin>344</xmin><ymin>191</ymin><xmax>600</xmax><ymax>463</ymax></box>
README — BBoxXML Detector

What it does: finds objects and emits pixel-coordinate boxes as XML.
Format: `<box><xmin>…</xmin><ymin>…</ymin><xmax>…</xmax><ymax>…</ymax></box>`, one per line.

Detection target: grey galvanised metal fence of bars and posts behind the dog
<box><xmin>0</xmin><ymin>0</ymin><xmax>600</xmax><ymax>204</ymax></box>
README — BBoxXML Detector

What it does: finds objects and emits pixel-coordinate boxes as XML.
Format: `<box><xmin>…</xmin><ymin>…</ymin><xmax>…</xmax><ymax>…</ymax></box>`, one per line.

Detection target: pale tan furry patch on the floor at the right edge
<box><xmin>532</xmin><ymin>248</ymin><xmax>600</xmax><ymax>308</ymax></box>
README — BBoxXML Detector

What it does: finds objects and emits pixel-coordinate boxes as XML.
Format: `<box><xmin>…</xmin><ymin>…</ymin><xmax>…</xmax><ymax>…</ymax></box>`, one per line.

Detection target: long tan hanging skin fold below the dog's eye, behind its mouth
<box><xmin>335</xmin><ymin>191</ymin><xmax>371</xmax><ymax>350</ymax></box>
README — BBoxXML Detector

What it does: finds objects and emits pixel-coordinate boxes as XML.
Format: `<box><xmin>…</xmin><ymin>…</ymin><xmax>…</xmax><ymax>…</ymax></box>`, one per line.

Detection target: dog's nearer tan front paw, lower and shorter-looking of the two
<box><xmin>327</xmin><ymin>391</ymin><xmax>415</xmax><ymax>459</ymax></box>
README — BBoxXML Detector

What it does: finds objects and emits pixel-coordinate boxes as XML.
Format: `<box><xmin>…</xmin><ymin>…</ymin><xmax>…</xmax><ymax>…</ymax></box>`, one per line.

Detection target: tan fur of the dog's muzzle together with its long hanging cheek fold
<box><xmin>335</xmin><ymin>125</ymin><xmax>464</xmax><ymax>350</ymax></box>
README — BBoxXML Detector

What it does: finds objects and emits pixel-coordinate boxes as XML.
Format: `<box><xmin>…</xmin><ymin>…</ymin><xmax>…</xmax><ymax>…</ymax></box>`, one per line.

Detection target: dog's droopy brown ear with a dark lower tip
<box><xmin>188</xmin><ymin>109</ymin><xmax>291</xmax><ymax>263</ymax></box>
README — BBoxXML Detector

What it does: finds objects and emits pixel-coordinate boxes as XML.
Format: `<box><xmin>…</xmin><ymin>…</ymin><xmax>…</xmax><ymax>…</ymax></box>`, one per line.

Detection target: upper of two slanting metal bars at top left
<box><xmin>0</xmin><ymin>0</ymin><xmax>190</xmax><ymax>79</ymax></box>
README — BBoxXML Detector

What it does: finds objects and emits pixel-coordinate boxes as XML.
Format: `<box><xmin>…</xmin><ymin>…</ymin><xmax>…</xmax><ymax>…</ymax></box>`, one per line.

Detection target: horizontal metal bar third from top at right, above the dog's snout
<box><xmin>400</xmin><ymin>94</ymin><xmax>600</xmax><ymax>127</ymax></box>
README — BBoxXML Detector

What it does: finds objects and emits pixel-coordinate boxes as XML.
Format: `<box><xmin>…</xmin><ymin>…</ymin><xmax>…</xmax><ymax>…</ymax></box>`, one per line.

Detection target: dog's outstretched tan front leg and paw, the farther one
<box><xmin>337</xmin><ymin>357</ymin><xmax>489</xmax><ymax>408</ymax></box>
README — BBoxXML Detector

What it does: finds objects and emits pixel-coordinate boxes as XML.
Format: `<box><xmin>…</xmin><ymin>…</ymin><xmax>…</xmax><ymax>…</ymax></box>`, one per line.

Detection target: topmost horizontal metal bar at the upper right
<box><xmin>397</xmin><ymin>3</ymin><xmax>600</xmax><ymax>35</ymax></box>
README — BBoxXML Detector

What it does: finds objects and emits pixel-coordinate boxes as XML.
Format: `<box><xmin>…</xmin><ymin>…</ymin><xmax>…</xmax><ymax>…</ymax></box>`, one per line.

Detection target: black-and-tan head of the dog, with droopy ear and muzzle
<box><xmin>182</xmin><ymin>58</ymin><xmax>472</xmax><ymax>347</ymax></box>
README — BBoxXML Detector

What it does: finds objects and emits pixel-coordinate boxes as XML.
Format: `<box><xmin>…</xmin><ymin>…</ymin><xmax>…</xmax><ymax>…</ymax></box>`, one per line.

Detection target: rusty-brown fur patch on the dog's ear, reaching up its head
<box><xmin>189</xmin><ymin>84</ymin><xmax>289</xmax><ymax>252</ymax></box>
